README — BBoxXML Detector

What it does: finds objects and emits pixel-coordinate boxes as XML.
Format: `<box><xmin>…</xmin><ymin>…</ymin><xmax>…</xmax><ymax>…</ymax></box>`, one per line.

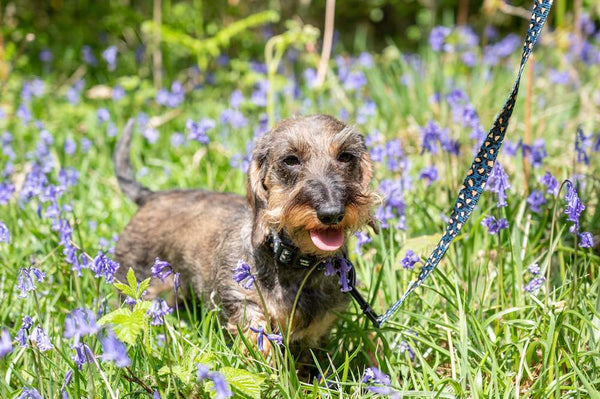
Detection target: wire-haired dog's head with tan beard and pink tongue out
<box><xmin>248</xmin><ymin>115</ymin><xmax>374</xmax><ymax>256</ymax></box>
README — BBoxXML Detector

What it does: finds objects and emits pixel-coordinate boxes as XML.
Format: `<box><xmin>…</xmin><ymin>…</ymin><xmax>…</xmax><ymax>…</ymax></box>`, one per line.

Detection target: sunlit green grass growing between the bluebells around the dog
<box><xmin>0</xmin><ymin>22</ymin><xmax>600</xmax><ymax>398</ymax></box>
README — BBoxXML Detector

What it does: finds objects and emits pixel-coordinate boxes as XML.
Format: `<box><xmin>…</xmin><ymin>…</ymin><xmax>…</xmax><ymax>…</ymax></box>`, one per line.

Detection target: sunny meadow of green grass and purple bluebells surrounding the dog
<box><xmin>0</xmin><ymin>1</ymin><xmax>600</xmax><ymax>398</ymax></box>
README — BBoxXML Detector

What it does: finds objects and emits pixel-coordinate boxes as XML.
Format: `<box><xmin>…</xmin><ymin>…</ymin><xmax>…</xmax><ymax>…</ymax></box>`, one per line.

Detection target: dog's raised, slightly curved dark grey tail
<box><xmin>113</xmin><ymin>118</ymin><xmax>152</xmax><ymax>205</ymax></box>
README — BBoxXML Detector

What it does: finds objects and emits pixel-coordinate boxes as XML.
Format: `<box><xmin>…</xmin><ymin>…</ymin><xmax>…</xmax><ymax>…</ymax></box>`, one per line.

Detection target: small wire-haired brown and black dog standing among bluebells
<box><xmin>114</xmin><ymin>115</ymin><xmax>375</xmax><ymax>353</ymax></box>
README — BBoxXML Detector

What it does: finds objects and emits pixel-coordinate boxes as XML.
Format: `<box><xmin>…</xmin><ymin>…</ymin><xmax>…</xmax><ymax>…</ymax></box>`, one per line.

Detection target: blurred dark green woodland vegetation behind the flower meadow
<box><xmin>0</xmin><ymin>0</ymin><xmax>600</xmax><ymax>84</ymax></box>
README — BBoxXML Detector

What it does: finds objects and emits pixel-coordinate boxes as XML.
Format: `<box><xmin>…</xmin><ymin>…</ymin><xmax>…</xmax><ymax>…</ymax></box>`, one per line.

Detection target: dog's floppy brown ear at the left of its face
<box><xmin>246</xmin><ymin>144</ymin><xmax>269</xmax><ymax>248</ymax></box>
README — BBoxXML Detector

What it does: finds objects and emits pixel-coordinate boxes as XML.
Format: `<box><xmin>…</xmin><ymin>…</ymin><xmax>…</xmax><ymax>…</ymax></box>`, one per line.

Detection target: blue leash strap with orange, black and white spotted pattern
<box><xmin>374</xmin><ymin>0</ymin><xmax>552</xmax><ymax>325</ymax></box>
